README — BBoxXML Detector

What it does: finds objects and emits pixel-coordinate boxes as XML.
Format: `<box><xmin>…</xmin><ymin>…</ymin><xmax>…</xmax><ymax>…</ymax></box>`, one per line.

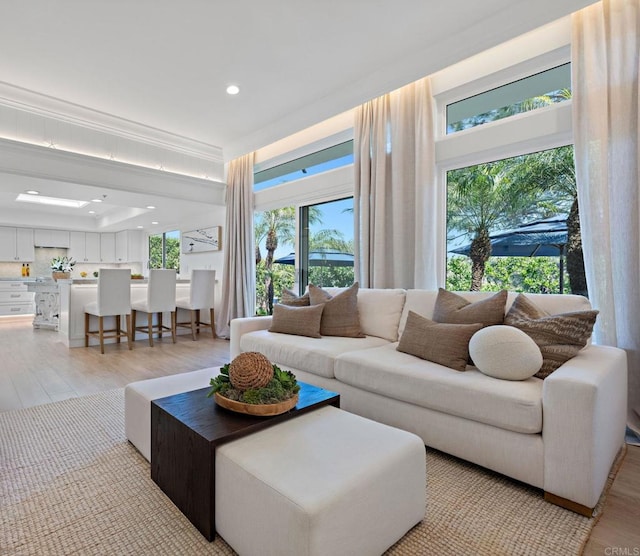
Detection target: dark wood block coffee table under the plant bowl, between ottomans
<box><xmin>151</xmin><ymin>382</ymin><xmax>340</xmax><ymax>541</ymax></box>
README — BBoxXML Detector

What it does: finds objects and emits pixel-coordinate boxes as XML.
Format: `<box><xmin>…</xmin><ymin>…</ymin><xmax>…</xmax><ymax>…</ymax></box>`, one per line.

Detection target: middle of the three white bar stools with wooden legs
<box><xmin>131</xmin><ymin>269</ymin><xmax>176</xmax><ymax>347</ymax></box>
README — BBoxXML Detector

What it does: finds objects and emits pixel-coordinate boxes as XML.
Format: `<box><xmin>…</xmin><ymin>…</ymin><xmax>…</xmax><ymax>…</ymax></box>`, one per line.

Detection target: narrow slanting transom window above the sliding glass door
<box><xmin>253</xmin><ymin>141</ymin><xmax>353</xmax><ymax>191</ymax></box>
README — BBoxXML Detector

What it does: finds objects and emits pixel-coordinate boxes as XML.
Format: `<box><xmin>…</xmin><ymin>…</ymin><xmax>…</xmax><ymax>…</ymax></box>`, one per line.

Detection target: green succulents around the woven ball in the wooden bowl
<box><xmin>207</xmin><ymin>363</ymin><xmax>300</xmax><ymax>405</ymax></box>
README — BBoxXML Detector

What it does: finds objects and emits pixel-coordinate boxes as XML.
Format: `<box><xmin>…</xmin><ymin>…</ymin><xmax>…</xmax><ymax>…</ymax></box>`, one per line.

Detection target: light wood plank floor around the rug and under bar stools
<box><xmin>0</xmin><ymin>317</ymin><xmax>640</xmax><ymax>556</ymax></box>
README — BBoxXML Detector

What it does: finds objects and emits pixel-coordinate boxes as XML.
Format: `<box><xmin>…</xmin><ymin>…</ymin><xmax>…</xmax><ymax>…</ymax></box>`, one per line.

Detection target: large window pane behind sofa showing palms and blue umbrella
<box><xmin>447</xmin><ymin>145</ymin><xmax>585</xmax><ymax>293</ymax></box>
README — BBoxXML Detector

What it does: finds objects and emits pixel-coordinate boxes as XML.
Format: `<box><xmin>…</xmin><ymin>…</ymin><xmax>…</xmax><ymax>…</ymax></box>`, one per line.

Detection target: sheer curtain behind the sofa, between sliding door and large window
<box><xmin>354</xmin><ymin>78</ymin><xmax>445</xmax><ymax>288</ymax></box>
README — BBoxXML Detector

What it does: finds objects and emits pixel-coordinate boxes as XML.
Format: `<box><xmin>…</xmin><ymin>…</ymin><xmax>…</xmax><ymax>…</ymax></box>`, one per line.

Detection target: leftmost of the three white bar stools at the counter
<box><xmin>83</xmin><ymin>268</ymin><xmax>131</xmax><ymax>354</ymax></box>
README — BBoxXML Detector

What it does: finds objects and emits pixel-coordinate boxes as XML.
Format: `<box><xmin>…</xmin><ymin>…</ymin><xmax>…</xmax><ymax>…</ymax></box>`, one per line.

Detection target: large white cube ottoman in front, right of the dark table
<box><xmin>215</xmin><ymin>407</ymin><xmax>426</xmax><ymax>556</ymax></box>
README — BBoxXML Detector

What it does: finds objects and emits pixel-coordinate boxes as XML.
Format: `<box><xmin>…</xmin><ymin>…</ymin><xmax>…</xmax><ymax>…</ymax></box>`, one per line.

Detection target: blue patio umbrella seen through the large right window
<box><xmin>449</xmin><ymin>215</ymin><xmax>567</xmax><ymax>293</ymax></box>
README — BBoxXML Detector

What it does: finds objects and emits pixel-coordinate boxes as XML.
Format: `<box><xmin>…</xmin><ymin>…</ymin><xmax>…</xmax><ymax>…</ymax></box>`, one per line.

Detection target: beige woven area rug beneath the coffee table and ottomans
<box><xmin>0</xmin><ymin>390</ymin><xmax>620</xmax><ymax>556</ymax></box>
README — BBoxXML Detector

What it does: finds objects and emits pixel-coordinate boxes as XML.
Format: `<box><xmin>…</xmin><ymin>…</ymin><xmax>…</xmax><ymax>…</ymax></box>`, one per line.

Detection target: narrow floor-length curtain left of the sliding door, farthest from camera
<box><xmin>217</xmin><ymin>153</ymin><xmax>256</xmax><ymax>338</ymax></box>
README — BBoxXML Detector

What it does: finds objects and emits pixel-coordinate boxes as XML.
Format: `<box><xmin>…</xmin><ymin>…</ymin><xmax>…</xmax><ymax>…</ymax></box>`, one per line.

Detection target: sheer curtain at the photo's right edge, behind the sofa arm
<box><xmin>572</xmin><ymin>0</ymin><xmax>640</xmax><ymax>440</ymax></box>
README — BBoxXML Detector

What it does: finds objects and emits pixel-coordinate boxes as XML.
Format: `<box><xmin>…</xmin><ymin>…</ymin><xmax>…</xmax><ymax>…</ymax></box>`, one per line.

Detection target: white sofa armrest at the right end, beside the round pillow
<box><xmin>542</xmin><ymin>345</ymin><xmax>627</xmax><ymax>508</ymax></box>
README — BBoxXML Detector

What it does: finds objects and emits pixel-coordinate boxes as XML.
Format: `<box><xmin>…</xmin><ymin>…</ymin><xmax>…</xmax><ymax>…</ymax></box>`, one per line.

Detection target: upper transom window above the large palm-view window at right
<box><xmin>446</xmin><ymin>63</ymin><xmax>571</xmax><ymax>134</ymax></box>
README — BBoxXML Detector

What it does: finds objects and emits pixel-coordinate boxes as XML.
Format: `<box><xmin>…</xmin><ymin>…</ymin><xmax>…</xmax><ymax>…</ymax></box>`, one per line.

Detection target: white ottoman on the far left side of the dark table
<box><xmin>124</xmin><ymin>367</ymin><xmax>220</xmax><ymax>461</ymax></box>
